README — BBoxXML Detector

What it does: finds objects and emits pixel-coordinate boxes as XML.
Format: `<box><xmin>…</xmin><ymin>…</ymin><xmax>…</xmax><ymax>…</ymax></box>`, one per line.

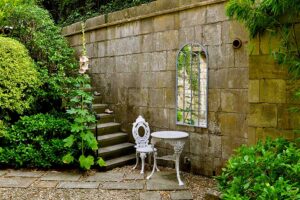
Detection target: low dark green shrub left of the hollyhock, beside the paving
<box><xmin>0</xmin><ymin>114</ymin><xmax>72</xmax><ymax>168</ymax></box>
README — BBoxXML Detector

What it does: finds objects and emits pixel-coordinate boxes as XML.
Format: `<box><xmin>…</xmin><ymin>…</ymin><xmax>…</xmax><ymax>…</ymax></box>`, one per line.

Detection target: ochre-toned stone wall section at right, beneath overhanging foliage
<box><xmin>248</xmin><ymin>29</ymin><xmax>300</xmax><ymax>144</ymax></box>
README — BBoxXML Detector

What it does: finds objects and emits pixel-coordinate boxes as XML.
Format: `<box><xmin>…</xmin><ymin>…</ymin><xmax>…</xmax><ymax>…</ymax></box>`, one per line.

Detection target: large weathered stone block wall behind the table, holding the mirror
<box><xmin>63</xmin><ymin>0</ymin><xmax>251</xmax><ymax>175</ymax></box>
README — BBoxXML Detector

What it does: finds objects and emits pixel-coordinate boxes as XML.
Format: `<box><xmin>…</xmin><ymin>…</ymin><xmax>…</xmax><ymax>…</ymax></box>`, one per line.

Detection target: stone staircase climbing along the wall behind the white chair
<box><xmin>91</xmin><ymin>97</ymin><xmax>135</xmax><ymax>170</ymax></box>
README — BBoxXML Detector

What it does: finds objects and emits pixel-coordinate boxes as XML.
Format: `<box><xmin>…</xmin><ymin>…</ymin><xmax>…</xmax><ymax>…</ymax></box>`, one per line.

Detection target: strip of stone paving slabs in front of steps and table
<box><xmin>0</xmin><ymin>169</ymin><xmax>214</xmax><ymax>200</ymax></box>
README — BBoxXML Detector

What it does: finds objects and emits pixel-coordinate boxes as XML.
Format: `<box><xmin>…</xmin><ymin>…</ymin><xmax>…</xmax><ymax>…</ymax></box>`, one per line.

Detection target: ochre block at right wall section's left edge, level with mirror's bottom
<box><xmin>248</xmin><ymin>104</ymin><xmax>277</xmax><ymax>127</ymax></box>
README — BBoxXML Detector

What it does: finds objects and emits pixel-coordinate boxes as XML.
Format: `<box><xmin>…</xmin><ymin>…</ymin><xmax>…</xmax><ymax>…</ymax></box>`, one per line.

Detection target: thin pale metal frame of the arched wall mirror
<box><xmin>175</xmin><ymin>42</ymin><xmax>209</xmax><ymax>128</ymax></box>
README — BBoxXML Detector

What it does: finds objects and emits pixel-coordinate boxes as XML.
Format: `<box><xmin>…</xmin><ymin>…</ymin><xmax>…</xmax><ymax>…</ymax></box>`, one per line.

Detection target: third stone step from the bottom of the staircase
<box><xmin>97</xmin><ymin>132</ymin><xmax>128</xmax><ymax>148</ymax></box>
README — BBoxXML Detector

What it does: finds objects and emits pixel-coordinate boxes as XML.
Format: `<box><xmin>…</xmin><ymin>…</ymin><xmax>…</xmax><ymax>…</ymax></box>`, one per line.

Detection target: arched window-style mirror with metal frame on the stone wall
<box><xmin>176</xmin><ymin>43</ymin><xmax>208</xmax><ymax>128</ymax></box>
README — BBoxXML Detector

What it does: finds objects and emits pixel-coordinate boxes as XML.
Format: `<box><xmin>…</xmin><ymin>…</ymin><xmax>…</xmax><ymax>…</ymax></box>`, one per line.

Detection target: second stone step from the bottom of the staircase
<box><xmin>98</xmin><ymin>142</ymin><xmax>135</xmax><ymax>160</ymax></box>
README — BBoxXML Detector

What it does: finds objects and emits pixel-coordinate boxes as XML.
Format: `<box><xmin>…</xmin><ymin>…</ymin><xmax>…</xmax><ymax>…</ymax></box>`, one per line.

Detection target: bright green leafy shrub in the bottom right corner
<box><xmin>217</xmin><ymin>138</ymin><xmax>300</xmax><ymax>200</ymax></box>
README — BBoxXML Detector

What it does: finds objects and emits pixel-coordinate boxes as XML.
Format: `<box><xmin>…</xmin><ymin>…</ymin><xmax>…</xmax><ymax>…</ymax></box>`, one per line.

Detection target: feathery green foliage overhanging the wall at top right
<box><xmin>227</xmin><ymin>0</ymin><xmax>300</xmax><ymax>119</ymax></box>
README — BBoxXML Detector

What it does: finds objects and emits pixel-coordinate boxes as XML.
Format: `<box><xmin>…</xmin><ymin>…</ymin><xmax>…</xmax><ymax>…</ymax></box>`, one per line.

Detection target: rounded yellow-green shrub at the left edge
<box><xmin>0</xmin><ymin>36</ymin><xmax>41</xmax><ymax>119</ymax></box>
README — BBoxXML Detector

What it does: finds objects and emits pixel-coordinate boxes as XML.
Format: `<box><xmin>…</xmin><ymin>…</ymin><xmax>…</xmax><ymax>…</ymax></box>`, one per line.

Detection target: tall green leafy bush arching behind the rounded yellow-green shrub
<box><xmin>0</xmin><ymin>0</ymin><xmax>78</xmax><ymax>113</ymax></box>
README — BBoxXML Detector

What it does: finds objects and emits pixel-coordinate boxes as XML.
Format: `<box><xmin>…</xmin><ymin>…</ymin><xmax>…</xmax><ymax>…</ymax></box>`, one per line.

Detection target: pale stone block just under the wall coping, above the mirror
<box><xmin>179</xmin><ymin>7</ymin><xmax>206</xmax><ymax>27</ymax></box>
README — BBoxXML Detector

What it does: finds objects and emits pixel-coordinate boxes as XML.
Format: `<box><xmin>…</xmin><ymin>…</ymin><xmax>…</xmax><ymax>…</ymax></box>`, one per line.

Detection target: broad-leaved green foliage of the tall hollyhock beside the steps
<box><xmin>63</xmin><ymin>74</ymin><xmax>105</xmax><ymax>170</ymax></box>
